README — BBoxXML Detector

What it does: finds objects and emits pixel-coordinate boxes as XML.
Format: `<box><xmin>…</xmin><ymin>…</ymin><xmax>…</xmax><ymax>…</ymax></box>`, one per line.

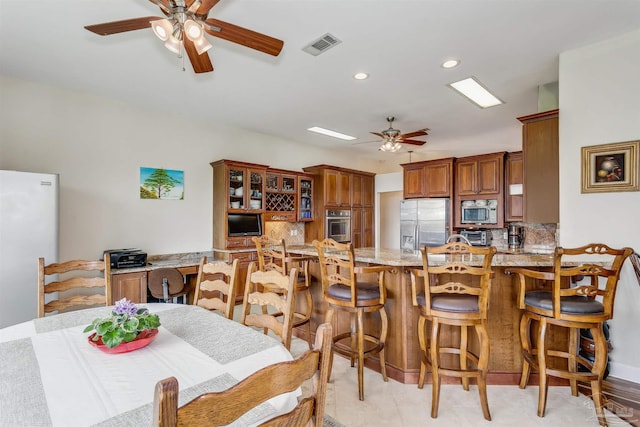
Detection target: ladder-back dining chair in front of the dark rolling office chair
<box><xmin>193</xmin><ymin>256</ymin><xmax>238</xmax><ymax>320</ymax></box>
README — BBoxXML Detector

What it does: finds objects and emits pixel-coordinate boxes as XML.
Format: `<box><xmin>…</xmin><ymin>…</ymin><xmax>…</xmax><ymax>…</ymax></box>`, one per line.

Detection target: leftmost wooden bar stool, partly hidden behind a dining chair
<box><xmin>252</xmin><ymin>235</ymin><xmax>313</xmax><ymax>348</ymax></box>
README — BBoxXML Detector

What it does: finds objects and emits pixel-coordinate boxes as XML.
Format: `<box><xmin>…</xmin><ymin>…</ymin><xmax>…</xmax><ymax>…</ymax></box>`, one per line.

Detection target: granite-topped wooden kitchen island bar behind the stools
<box><xmin>287</xmin><ymin>245</ymin><xmax>566</xmax><ymax>384</ymax></box>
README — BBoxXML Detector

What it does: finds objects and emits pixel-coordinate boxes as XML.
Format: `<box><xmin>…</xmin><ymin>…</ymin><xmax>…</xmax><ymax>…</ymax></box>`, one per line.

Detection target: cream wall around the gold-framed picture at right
<box><xmin>560</xmin><ymin>30</ymin><xmax>640</xmax><ymax>382</ymax></box>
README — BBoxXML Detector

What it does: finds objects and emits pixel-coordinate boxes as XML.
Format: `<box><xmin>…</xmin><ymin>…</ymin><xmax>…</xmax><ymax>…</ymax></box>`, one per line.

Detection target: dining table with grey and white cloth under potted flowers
<box><xmin>0</xmin><ymin>303</ymin><xmax>300</xmax><ymax>427</ymax></box>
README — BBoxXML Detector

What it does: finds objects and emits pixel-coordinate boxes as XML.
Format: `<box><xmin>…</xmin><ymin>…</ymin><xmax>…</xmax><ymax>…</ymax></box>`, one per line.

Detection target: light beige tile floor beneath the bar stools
<box><xmin>291</xmin><ymin>337</ymin><xmax>628</xmax><ymax>427</ymax></box>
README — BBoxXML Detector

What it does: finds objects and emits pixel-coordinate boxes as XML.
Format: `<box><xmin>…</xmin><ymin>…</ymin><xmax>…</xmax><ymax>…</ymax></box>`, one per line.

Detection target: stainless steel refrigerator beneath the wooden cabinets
<box><xmin>400</xmin><ymin>199</ymin><xmax>450</xmax><ymax>251</ymax></box>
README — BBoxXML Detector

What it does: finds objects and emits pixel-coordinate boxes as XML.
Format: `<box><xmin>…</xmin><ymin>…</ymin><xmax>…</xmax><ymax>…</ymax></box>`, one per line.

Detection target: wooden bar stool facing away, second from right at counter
<box><xmin>411</xmin><ymin>242</ymin><xmax>496</xmax><ymax>421</ymax></box>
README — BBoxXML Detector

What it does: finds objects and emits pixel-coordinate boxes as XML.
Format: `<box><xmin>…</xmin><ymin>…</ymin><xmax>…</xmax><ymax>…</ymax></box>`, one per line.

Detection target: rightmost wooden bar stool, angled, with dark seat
<box><xmin>505</xmin><ymin>243</ymin><xmax>633</xmax><ymax>425</ymax></box>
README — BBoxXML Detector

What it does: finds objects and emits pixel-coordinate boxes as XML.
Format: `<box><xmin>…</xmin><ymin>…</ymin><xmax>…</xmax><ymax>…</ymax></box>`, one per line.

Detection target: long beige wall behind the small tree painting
<box><xmin>0</xmin><ymin>76</ymin><xmax>378</xmax><ymax>259</ymax></box>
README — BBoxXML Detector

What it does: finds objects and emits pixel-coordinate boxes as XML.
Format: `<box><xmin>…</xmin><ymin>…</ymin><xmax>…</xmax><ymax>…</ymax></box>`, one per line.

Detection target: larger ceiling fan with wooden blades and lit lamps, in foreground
<box><xmin>85</xmin><ymin>0</ymin><xmax>284</xmax><ymax>73</ymax></box>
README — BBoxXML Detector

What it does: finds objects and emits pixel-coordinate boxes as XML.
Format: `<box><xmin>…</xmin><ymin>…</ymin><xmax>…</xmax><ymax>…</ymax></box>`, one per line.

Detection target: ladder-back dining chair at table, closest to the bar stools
<box><xmin>240</xmin><ymin>262</ymin><xmax>298</xmax><ymax>350</ymax></box>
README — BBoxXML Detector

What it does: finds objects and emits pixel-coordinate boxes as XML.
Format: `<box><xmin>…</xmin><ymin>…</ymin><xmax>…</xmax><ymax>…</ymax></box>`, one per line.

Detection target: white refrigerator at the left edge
<box><xmin>0</xmin><ymin>170</ymin><xmax>59</xmax><ymax>328</ymax></box>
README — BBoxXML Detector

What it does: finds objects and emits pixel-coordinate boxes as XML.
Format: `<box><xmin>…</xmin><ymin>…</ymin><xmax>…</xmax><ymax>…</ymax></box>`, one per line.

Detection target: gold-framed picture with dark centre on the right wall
<box><xmin>582</xmin><ymin>141</ymin><xmax>640</xmax><ymax>193</ymax></box>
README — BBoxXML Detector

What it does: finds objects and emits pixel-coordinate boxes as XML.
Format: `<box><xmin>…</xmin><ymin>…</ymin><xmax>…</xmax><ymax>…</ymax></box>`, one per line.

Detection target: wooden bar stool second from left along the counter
<box><xmin>313</xmin><ymin>239</ymin><xmax>393</xmax><ymax>400</ymax></box>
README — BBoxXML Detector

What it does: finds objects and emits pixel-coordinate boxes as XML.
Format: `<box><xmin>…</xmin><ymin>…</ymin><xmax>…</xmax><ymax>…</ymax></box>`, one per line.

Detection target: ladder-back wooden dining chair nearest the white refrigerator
<box><xmin>38</xmin><ymin>253</ymin><xmax>112</xmax><ymax>317</ymax></box>
